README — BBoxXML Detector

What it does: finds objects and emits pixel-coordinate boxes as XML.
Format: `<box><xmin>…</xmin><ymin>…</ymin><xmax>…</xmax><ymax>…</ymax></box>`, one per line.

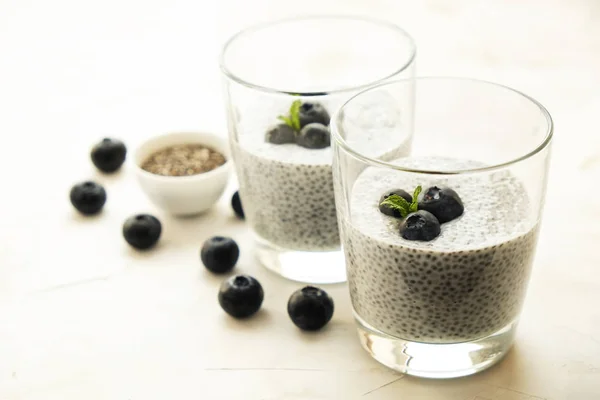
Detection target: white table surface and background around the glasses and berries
<box><xmin>0</xmin><ymin>0</ymin><xmax>600</xmax><ymax>400</ymax></box>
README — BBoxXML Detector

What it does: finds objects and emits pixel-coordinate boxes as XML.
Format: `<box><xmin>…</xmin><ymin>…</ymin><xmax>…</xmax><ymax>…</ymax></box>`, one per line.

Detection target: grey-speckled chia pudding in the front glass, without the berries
<box><xmin>340</xmin><ymin>158</ymin><xmax>538</xmax><ymax>343</ymax></box>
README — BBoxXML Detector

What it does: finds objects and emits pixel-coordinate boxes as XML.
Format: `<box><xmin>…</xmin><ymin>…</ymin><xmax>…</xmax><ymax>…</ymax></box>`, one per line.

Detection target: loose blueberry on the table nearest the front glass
<box><xmin>288</xmin><ymin>286</ymin><xmax>333</xmax><ymax>331</ymax></box>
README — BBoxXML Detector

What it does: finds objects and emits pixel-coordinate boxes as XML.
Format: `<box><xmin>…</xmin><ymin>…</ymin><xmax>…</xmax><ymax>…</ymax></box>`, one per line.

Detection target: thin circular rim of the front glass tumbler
<box><xmin>330</xmin><ymin>76</ymin><xmax>554</xmax><ymax>175</ymax></box>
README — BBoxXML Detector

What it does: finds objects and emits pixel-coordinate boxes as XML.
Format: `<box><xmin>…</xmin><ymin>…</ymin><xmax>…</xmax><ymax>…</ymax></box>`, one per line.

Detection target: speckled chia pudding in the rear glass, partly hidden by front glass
<box><xmin>231</xmin><ymin>99</ymin><xmax>410</xmax><ymax>251</ymax></box>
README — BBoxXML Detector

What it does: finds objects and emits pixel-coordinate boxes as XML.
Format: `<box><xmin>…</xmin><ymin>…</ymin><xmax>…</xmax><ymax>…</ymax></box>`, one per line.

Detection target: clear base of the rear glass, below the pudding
<box><xmin>256</xmin><ymin>238</ymin><xmax>346</xmax><ymax>284</ymax></box>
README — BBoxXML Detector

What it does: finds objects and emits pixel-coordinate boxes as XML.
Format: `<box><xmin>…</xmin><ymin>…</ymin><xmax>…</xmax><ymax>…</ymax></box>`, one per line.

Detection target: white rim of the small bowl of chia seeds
<box><xmin>132</xmin><ymin>130</ymin><xmax>232</xmax><ymax>182</ymax></box>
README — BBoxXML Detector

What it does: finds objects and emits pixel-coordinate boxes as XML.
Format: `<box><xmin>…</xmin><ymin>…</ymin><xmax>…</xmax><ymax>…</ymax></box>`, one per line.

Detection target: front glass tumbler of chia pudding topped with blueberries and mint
<box><xmin>332</xmin><ymin>78</ymin><xmax>553</xmax><ymax>378</ymax></box>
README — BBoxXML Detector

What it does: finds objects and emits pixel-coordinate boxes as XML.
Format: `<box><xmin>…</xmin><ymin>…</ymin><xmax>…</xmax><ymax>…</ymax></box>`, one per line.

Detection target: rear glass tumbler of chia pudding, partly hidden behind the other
<box><xmin>221</xmin><ymin>17</ymin><xmax>415</xmax><ymax>283</ymax></box>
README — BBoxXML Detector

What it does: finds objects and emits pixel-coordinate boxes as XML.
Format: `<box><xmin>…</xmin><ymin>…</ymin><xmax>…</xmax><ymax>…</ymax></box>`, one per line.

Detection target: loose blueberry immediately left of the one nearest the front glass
<box><xmin>219</xmin><ymin>275</ymin><xmax>265</xmax><ymax>318</ymax></box>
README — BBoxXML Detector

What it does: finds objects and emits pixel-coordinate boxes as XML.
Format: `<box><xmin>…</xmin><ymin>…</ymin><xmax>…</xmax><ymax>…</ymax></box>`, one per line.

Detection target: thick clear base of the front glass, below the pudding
<box><xmin>355</xmin><ymin>313</ymin><xmax>517</xmax><ymax>379</ymax></box>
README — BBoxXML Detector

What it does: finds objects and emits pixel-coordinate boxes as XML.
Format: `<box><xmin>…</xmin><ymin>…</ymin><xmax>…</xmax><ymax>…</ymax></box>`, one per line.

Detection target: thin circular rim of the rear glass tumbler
<box><xmin>219</xmin><ymin>14</ymin><xmax>417</xmax><ymax>96</ymax></box>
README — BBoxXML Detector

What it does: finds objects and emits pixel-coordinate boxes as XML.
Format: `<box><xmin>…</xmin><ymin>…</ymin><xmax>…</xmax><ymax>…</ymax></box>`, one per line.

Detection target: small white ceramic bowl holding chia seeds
<box><xmin>134</xmin><ymin>132</ymin><xmax>232</xmax><ymax>216</ymax></box>
